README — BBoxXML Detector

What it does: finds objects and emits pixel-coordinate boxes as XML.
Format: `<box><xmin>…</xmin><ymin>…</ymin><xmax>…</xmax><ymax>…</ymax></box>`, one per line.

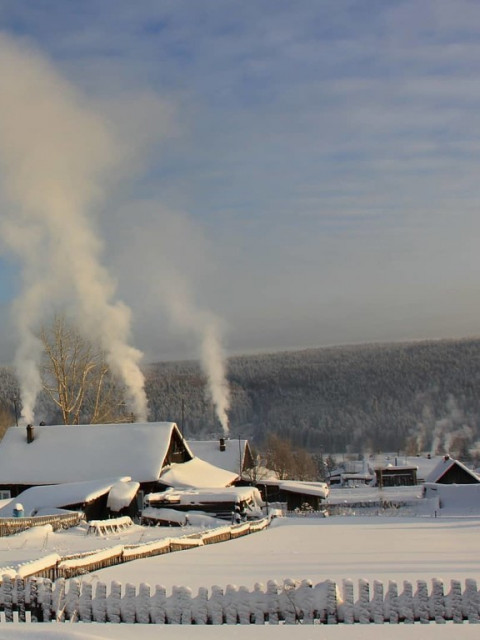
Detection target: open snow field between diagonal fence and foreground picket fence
<box><xmin>95</xmin><ymin>517</ymin><xmax>480</xmax><ymax>591</ymax></box>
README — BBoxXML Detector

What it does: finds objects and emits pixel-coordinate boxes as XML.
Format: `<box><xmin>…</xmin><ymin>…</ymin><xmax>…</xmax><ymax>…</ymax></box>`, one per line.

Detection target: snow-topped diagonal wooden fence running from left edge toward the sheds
<box><xmin>0</xmin><ymin>518</ymin><xmax>270</xmax><ymax>580</ymax></box>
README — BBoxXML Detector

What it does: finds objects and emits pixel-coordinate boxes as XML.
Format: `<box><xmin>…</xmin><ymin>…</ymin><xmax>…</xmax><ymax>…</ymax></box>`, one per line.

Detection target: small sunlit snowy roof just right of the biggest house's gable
<box><xmin>160</xmin><ymin>458</ymin><xmax>238</xmax><ymax>489</ymax></box>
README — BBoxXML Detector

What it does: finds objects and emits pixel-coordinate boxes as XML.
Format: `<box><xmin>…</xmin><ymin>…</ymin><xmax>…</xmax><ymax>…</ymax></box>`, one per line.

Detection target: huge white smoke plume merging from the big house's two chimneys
<box><xmin>0</xmin><ymin>34</ymin><xmax>147</xmax><ymax>421</ymax></box>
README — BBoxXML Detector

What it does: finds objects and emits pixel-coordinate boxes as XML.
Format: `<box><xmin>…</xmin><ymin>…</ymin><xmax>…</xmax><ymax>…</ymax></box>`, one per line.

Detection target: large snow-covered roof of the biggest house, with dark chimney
<box><xmin>0</xmin><ymin>422</ymin><xmax>189</xmax><ymax>485</ymax></box>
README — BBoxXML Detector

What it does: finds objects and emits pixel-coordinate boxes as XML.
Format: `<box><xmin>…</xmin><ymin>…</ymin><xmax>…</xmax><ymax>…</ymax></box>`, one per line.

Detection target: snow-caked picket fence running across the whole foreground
<box><xmin>0</xmin><ymin>576</ymin><xmax>480</xmax><ymax>625</ymax></box>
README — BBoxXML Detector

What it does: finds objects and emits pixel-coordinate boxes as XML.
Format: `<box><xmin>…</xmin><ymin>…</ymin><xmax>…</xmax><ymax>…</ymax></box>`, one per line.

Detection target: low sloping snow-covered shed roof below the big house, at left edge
<box><xmin>0</xmin><ymin>476</ymin><xmax>130</xmax><ymax>518</ymax></box>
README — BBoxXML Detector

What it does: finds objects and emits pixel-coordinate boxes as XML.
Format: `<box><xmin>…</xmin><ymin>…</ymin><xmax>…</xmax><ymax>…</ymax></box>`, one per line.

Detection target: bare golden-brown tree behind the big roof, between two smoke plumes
<box><xmin>39</xmin><ymin>314</ymin><xmax>130</xmax><ymax>424</ymax></box>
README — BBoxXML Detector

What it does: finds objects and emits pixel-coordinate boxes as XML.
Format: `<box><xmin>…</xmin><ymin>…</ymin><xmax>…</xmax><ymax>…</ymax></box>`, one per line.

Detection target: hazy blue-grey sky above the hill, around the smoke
<box><xmin>0</xmin><ymin>0</ymin><xmax>480</xmax><ymax>363</ymax></box>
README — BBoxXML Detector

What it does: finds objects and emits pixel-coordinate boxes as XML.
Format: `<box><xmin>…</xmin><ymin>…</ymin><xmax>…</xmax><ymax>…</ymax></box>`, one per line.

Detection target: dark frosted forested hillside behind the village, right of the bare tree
<box><xmin>147</xmin><ymin>339</ymin><xmax>480</xmax><ymax>455</ymax></box>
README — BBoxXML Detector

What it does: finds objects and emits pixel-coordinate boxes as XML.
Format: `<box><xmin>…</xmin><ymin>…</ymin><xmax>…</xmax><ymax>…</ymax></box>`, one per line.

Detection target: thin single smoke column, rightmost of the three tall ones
<box><xmin>162</xmin><ymin>276</ymin><xmax>230</xmax><ymax>435</ymax></box>
